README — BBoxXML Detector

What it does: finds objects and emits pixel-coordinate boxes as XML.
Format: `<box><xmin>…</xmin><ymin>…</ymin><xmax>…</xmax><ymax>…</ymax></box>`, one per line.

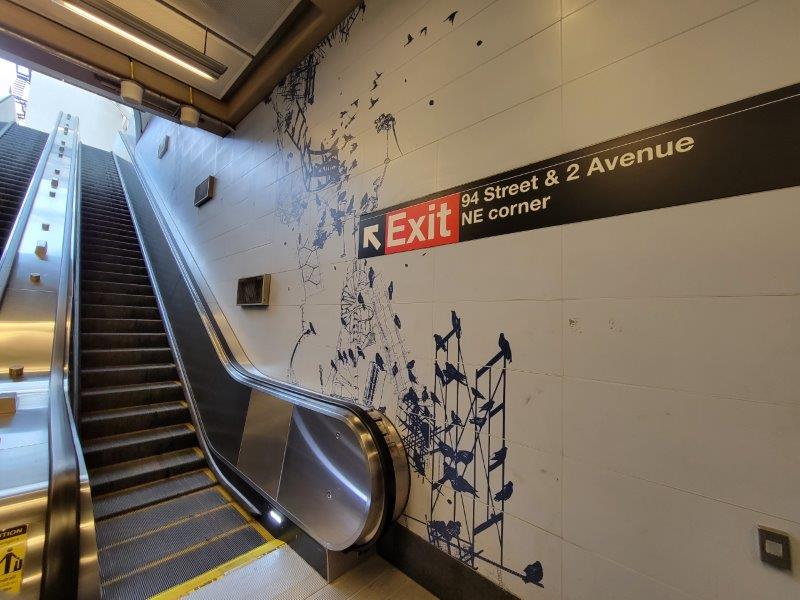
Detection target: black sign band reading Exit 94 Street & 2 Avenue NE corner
<box><xmin>358</xmin><ymin>84</ymin><xmax>800</xmax><ymax>258</ymax></box>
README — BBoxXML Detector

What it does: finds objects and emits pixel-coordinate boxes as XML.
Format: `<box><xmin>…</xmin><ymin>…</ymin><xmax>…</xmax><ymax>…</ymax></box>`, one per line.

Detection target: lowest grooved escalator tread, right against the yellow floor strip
<box><xmin>103</xmin><ymin>525</ymin><xmax>265</xmax><ymax>600</ymax></box>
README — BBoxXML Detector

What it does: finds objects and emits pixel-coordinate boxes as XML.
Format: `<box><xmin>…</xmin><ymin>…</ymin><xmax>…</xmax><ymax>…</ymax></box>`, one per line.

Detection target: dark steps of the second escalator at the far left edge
<box><xmin>0</xmin><ymin>123</ymin><xmax>47</xmax><ymax>253</ymax></box>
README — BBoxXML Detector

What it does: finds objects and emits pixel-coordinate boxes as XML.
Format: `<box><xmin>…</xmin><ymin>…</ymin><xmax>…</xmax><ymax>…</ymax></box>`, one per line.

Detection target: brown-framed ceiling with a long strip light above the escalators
<box><xmin>0</xmin><ymin>0</ymin><xmax>358</xmax><ymax>134</ymax></box>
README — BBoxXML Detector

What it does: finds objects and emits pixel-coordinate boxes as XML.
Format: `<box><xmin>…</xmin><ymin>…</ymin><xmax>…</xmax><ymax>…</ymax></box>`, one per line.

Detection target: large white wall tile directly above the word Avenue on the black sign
<box><xmin>564</xmin><ymin>0</ymin><xmax>800</xmax><ymax>148</ymax></box>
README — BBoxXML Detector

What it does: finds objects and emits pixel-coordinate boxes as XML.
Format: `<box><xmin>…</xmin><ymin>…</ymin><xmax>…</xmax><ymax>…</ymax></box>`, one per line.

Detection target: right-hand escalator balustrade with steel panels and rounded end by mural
<box><xmin>115</xmin><ymin>132</ymin><xmax>409</xmax><ymax>550</ymax></box>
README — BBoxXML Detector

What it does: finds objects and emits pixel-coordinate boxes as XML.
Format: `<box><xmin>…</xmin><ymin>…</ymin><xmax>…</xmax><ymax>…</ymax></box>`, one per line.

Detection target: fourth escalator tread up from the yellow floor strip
<box><xmin>92</xmin><ymin>469</ymin><xmax>216</xmax><ymax>522</ymax></box>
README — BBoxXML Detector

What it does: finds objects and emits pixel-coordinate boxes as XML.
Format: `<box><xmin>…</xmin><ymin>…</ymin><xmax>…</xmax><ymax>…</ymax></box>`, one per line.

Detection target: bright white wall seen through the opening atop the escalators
<box><xmin>24</xmin><ymin>72</ymin><xmax>127</xmax><ymax>150</ymax></box>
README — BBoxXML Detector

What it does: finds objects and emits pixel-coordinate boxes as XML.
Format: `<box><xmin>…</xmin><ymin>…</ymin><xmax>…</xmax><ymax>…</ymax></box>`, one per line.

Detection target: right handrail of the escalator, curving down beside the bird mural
<box><xmin>120</xmin><ymin>136</ymin><xmax>407</xmax><ymax>545</ymax></box>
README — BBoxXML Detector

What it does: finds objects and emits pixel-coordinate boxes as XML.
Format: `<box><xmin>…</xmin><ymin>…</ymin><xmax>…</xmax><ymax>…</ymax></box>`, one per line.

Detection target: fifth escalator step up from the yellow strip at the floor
<box><xmin>89</xmin><ymin>448</ymin><xmax>205</xmax><ymax>495</ymax></box>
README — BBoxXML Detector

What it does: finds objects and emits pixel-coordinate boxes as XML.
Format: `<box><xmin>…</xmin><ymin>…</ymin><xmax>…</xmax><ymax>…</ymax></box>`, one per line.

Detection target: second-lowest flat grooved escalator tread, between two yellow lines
<box><xmin>99</xmin><ymin>504</ymin><xmax>252</xmax><ymax>580</ymax></box>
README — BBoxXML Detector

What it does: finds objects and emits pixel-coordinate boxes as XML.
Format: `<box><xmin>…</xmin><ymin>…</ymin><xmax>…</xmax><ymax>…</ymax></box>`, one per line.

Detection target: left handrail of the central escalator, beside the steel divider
<box><xmin>41</xmin><ymin>115</ymin><xmax>81</xmax><ymax>598</ymax></box>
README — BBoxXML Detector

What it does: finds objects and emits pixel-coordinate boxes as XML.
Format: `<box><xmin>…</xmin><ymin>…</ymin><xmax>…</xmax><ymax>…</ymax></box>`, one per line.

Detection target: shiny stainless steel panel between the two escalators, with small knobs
<box><xmin>0</xmin><ymin>115</ymin><xmax>63</xmax><ymax>599</ymax></box>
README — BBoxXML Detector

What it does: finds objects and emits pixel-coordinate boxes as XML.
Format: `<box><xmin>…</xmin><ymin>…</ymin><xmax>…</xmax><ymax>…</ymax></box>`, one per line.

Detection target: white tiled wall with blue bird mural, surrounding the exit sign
<box><xmin>136</xmin><ymin>0</ymin><xmax>800</xmax><ymax>600</ymax></box>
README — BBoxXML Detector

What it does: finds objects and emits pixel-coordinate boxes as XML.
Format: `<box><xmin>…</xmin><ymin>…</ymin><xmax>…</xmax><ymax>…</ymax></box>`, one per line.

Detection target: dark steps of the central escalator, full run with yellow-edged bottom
<box><xmin>77</xmin><ymin>146</ymin><xmax>272</xmax><ymax>599</ymax></box>
